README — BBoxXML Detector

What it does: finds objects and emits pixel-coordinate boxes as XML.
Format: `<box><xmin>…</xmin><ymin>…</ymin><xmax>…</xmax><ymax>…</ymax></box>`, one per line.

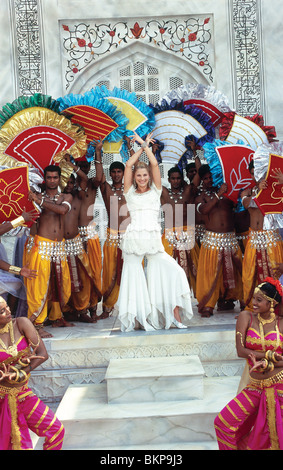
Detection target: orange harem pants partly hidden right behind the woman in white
<box><xmin>162</xmin><ymin>227</ymin><xmax>200</xmax><ymax>296</ymax></box>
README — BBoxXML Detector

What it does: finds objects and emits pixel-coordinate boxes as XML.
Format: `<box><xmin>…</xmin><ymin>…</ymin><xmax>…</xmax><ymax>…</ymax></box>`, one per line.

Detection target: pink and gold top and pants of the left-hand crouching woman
<box><xmin>0</xmin><ymin>336</ymin><xmax>65</xmax><ymax>450</ymax></box>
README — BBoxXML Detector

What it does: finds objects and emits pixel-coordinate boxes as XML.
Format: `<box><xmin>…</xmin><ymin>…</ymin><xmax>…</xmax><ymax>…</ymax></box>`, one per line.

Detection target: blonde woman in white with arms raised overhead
<box><xmin>118</xmin><ymin>130</ymin><xmax>193</xmax><ymax>331</ymax></box>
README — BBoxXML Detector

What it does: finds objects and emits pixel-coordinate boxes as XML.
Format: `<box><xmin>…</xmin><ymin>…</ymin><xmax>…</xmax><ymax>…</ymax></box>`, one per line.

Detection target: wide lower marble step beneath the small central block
<box><xmin>53</xmin><ymin>377</ymin><xmax>240</xmax><ymax>450</ymax></box>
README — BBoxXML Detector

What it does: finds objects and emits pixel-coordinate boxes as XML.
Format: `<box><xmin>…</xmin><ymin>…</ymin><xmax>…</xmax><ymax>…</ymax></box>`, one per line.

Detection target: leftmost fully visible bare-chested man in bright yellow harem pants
<box><xmin>26</xmin><ymin>165</ymin><xmax>72</xmax><ymax>338</ymax></box>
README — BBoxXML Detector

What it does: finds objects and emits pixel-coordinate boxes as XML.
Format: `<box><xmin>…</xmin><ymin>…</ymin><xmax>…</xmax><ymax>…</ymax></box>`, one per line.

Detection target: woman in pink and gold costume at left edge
<box><xmin>0</xmin><ymin>297</ymin><xmax>65</xmax><ymax>450</ymax></box>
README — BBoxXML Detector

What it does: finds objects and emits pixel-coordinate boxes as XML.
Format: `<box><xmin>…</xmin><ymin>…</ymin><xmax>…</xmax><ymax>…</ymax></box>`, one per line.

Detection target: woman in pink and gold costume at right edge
<box><xmin>214</xmin><ymin>278</ymin><xmax>283</xmax><ymax>450</ymax></box>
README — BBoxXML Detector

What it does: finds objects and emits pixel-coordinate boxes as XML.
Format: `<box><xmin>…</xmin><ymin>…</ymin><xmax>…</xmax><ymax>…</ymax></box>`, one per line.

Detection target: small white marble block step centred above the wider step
<box><xmin>105</xmin><ymin>356</ymin><xmax>204</xmax><ymax>403</ymax></box>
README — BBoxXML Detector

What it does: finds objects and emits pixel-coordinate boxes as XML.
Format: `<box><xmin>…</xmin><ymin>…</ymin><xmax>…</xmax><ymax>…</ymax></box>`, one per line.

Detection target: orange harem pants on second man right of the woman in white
<box><xmin>196</xmin><ymin>231</ymin><xmax>243</xmax><ymax>312</ymax></box>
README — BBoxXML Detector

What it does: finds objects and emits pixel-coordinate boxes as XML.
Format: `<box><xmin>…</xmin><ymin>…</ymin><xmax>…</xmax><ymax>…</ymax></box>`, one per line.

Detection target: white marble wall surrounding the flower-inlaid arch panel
<box><xmin>0</xmin><ymin>0</ymin><xmax>283</xmax><ymax>139</ymax></box>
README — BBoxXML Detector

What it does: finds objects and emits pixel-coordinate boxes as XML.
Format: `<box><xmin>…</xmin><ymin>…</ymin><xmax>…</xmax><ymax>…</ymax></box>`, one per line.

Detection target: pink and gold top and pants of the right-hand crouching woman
<box><xmin>214</xmin><ymin>314</ymin><xmax>283</xmax><ymax>450</ymax></box>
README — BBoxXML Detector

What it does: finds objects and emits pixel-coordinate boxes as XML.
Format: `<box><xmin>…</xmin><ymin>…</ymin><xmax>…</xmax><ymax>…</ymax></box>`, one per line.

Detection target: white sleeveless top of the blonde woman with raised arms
<box><xmin>121</xmin><ymin>183</ymin><xmax>164</xmax><ymax>255</ymax></box>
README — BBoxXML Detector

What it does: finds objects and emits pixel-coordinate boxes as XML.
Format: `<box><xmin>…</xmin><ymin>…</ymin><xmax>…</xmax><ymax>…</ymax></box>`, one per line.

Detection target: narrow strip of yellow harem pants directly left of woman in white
<box><xmin>102</xmin><ymin>228</ymin><xmax>123</xmax><ymax>310</ymax></box>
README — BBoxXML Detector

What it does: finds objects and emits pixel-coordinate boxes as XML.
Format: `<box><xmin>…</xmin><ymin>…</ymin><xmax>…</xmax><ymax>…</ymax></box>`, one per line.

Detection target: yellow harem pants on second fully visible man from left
<box><xmin>64</xmin><ymin>235</ymin><xmax>101</xmax><ymax>312</ymax></box>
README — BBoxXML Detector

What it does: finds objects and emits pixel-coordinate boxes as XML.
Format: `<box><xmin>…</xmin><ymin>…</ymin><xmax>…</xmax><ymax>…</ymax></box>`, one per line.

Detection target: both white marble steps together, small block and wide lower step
<box><xmin>52</xmin><ymin>355</ymin><xmax>240</xmax><ymax>450</ymax></box>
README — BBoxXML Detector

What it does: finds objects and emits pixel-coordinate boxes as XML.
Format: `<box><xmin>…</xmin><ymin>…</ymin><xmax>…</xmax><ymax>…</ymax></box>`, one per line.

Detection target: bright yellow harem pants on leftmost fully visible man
<box><xmin>24</xmin><ymin>235</ymin><xmax>71</xmax><ymax>325</ymax></box>
